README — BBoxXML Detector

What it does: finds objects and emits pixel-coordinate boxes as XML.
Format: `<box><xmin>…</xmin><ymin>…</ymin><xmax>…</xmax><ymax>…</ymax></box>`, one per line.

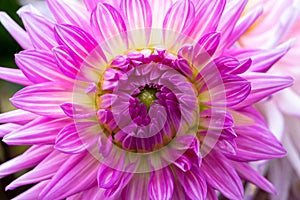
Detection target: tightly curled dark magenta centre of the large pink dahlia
<box><xmin>97</xmin><ymin>49</ymin><xmax>198</xmax><ymax>153</ymax></box>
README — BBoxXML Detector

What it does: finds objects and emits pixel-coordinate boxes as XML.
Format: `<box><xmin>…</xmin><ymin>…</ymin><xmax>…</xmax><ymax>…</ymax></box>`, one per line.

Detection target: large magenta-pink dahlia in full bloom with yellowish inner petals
<box><xmin>0</xmin><ymin>0</ymin><xmax>293</xmax><ymax>200</ymax></box>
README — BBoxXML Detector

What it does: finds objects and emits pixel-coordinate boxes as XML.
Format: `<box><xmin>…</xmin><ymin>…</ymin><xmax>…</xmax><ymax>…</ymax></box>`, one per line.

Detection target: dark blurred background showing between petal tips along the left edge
<box><xmin>0</xmin><ymin>0</ymin><xmax>27</xmax><ymax>200</ymax></box>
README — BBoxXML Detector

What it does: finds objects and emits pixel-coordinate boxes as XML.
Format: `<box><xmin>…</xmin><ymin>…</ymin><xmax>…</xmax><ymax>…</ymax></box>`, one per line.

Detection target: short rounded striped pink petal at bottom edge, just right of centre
<box><xmin>148</xmin><ymin>167</ymin><xmax>174</xmax><ymax>200</ymax></box>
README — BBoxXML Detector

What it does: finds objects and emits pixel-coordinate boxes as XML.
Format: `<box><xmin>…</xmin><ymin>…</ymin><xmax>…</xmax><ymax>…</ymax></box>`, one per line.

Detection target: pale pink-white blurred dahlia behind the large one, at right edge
<box><xmin>239</xmin><ymin>0</ymin><xmax>300</xmax><ymax>200</ymax></box>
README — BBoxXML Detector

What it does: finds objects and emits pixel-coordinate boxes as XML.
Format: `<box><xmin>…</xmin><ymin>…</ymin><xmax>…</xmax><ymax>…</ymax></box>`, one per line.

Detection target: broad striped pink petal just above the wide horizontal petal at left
<box><xmin>15</xmin><ymin>50</ymin><xmax>70</xmax><ymax>83</ymax></box>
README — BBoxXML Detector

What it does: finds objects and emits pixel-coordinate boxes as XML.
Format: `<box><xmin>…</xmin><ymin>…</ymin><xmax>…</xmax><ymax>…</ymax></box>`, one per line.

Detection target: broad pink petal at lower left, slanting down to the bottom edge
<box><xmin>39</xmin><ymin>153</ymin><xmax>100</xmax><ymax>199</ymax></box>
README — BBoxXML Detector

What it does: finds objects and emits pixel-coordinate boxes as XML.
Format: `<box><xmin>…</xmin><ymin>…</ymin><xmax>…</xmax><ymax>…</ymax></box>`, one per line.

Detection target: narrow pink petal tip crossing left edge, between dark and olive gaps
<box><xmin>0</xmin><ymin>67</ymin><xmax>32</xmax><ymax>85</ymax></box>
